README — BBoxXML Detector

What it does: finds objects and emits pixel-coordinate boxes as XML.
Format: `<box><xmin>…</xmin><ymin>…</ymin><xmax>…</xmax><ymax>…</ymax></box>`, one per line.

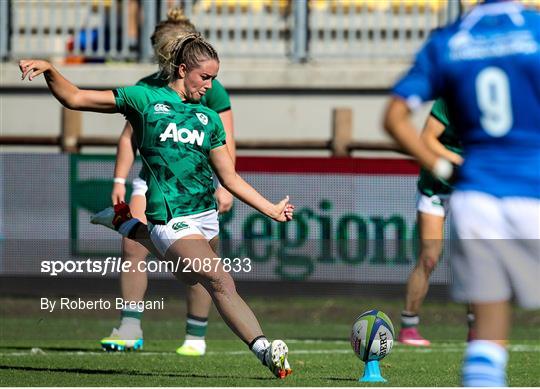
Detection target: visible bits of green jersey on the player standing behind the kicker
<box><xmin>135</xmin><ymin>72</ymin><xmax>231</xmax><ymax>181</ymax></box>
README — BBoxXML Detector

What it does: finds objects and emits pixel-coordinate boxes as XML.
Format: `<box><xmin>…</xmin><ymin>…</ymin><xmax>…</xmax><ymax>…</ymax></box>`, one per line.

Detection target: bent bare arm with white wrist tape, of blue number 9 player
<box><xmin>384</xmin><ymin>97</ymin><xmax>453</xmax><ymax>180</ymax></box>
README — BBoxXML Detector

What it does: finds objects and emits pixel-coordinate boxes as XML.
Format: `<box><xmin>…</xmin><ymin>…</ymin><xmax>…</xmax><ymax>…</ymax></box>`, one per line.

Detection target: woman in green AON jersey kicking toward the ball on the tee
<box><xmin>19</xmin><ymin>34</ymin><xmax>294</xmax><ymax>378</ymax></box>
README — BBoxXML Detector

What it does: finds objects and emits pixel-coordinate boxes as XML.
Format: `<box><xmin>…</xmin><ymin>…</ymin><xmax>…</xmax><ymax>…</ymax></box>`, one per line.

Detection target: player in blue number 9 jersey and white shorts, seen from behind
<box><xmin>385</xmin><ymin>0</ymin><xmax>540</xmax><ymax>386</ymax></box>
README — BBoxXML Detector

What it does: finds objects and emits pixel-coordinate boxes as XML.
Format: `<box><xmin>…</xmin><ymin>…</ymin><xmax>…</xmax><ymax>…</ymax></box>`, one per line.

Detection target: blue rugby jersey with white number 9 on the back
<box><xmin>393</xmin><ymin>2</ymin><xmax>540</xmax><ymax>198</ymax></box>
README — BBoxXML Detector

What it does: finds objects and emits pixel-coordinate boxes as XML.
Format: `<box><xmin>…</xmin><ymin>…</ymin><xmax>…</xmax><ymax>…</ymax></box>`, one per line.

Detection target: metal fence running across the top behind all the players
<box><xmin>0</xmin><ymin>0</ymin><xmax>540</xmax><ymax>62</ymax></box>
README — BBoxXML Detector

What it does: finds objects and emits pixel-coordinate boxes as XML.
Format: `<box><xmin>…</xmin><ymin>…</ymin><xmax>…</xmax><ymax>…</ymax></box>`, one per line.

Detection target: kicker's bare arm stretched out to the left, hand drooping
<box><xmin>19</xmin><ymin>59</ymin><xmax>117</xmax><ymax>113</ymax></box>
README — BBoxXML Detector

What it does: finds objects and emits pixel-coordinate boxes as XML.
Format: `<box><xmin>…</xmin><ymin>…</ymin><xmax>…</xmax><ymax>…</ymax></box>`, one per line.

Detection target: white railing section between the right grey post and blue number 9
<box><xmin>309</xmin><ymin>0</ymin><xmax>449</xmax><ymax>59</ymax></box>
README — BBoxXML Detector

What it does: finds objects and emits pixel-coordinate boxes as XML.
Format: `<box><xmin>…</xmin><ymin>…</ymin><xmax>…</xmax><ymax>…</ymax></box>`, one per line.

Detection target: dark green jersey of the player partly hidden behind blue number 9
<box><xmin>418</xmin><ymin>99</ymin><xmax>463</xmax><ymax>196</ymax></box>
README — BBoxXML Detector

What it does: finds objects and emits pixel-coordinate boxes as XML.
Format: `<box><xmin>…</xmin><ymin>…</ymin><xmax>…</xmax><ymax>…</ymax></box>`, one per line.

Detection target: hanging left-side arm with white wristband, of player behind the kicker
<box><xmin>111</xmin><ymin>121</ymin><xmax>135</xmax><ymax>204</ymax></box>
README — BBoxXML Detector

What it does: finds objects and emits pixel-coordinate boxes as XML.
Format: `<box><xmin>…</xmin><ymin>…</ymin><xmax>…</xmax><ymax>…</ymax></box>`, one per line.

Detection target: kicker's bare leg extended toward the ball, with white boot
<box><xmin>165</xmin><ymin>235</ymin><xmax>292</xmax><ymax>378</ymax></box>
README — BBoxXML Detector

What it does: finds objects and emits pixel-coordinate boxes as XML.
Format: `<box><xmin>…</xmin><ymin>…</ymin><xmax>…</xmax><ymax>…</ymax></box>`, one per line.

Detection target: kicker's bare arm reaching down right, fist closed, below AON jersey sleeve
<box><xmin>210</xmin><ymin>146</ymin><xmax>294</xmax><ymax>222</ymax></box>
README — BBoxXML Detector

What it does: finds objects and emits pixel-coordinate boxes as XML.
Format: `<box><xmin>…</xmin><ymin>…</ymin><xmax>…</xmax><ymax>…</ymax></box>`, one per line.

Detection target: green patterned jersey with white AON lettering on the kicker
<box><xmin>114</xmin><ymin>86</ymin><xmax>225</xmax><ymax>222</ymax></box>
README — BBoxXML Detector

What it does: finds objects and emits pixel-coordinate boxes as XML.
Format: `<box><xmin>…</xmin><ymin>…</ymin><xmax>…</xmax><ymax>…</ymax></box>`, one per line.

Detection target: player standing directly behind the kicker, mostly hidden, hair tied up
<box><xmin>101</xmin><ymin>8</ymin><xmax>236</xmax><ymax>356</ymax></box>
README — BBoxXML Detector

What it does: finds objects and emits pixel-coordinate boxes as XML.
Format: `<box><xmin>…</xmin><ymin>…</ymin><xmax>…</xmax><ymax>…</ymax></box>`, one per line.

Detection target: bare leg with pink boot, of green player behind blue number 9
<box><xmin>398</xmin><ymin>212</ymin><xmax>444</xmax><ymax>346</ymax></box>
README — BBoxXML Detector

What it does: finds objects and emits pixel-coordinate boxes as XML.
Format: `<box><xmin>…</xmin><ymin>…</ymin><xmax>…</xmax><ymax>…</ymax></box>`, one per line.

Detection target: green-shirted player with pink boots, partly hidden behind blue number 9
<box><xmin>398</xmin><ymin>99</ymin><xmax>474</xmax><ymax>346</ymax></box>
